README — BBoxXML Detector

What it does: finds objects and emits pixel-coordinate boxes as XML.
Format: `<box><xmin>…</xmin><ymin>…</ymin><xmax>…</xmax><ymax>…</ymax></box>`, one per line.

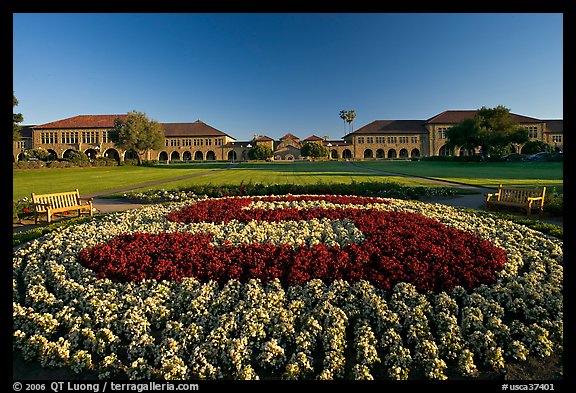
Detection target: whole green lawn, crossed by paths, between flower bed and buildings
<box><xmin>12</xmin><ymin>161</ymin><xmax>563</xmax><ymax>199</ymax></box>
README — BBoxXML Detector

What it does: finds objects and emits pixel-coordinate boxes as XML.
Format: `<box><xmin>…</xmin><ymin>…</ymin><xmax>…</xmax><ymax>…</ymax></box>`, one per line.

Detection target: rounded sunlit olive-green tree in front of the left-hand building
<box><xmin>109</xmin><ymin>111</ymin><xmax>164</xmax><ymax>165</ymax></box>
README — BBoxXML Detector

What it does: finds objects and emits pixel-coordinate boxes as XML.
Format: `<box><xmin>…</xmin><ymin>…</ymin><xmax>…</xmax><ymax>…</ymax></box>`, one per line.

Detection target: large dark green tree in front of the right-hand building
<box><xmin>446</xmin><ymin>105</ymin><xmax>528</xmax><ymax>156</ymax></box>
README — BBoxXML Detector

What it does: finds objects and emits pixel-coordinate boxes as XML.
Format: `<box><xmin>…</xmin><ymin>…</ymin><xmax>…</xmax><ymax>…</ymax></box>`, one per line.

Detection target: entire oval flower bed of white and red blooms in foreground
<box><xmin>13</xmin><ymin>196</ymin><xmax>563</xmax><ymax>379</ymax></box>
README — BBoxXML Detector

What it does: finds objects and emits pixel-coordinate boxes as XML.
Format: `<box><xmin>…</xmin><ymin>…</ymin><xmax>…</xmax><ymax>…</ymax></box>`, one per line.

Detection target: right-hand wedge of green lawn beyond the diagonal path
<box><xmin>354</xmin><ymin>160</ymin><xmax>564</xmax><ymax>192</ymax></box>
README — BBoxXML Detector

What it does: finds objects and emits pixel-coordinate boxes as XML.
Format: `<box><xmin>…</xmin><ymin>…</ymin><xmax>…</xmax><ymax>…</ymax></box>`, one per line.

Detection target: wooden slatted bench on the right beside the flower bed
<box><xmin>486</xmin><ymin>184</ymin><xmax>546</xmax><ymax>217</ymax></box>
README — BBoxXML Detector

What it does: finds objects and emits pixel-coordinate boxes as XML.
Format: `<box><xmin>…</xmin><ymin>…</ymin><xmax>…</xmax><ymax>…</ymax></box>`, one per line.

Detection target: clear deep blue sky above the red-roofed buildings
<box><xmin>13</xmin><ymin>13</ymin><xmax>563</xmax><ymax>140</ymax></box>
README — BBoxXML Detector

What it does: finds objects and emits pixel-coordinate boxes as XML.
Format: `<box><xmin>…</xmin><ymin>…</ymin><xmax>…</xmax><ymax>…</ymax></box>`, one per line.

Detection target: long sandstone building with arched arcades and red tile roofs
<box><xmin>13</xmin><ymin>110</ymin><xmax>564</xmax><ymax>162</ymax></box>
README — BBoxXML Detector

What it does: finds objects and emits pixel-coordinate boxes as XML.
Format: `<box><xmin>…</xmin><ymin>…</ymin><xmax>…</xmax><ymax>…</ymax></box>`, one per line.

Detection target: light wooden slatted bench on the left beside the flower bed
<box><xmin>32</xmin><ymin>189</ymin><xmax>94</xmax><ymax>224</ymax></box>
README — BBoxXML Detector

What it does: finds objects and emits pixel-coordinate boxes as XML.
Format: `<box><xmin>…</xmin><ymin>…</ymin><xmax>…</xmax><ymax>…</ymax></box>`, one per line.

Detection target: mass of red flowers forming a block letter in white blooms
<box><xmin>79</xmin><ymin>196</ymin><xmax>506</xmax><ymax>291</ymax></box>
